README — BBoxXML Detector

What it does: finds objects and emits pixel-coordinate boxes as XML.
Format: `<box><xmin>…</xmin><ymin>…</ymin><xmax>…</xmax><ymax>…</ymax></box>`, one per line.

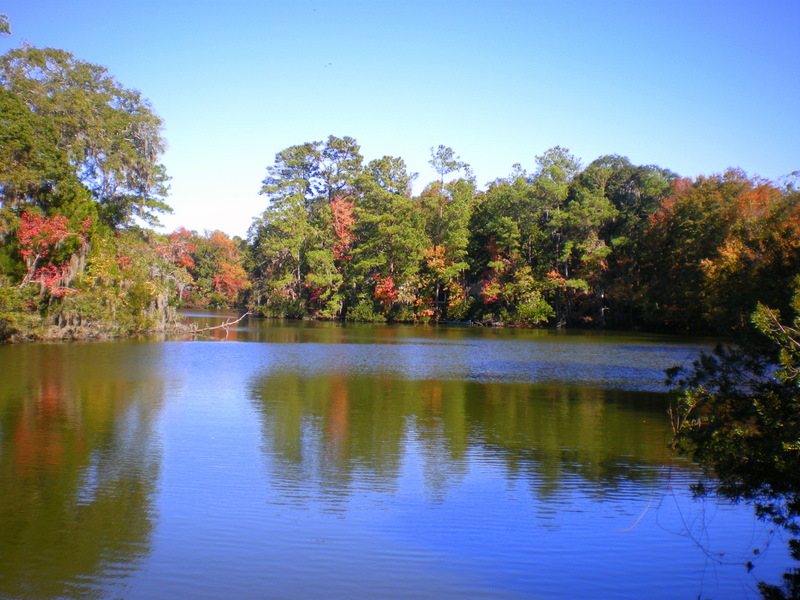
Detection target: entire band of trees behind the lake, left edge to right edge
<box><xmin>0</xmin><ymin>45</ymin><xmax>800</xmax><ymax>340</ymax></box>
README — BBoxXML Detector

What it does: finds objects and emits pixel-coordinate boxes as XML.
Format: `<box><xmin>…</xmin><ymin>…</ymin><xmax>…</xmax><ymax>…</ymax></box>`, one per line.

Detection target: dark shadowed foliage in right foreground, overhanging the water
<box><xmin>669</xmin><ymin>286</ymin><xmax>800</xmax><ymax>599</ymax></box>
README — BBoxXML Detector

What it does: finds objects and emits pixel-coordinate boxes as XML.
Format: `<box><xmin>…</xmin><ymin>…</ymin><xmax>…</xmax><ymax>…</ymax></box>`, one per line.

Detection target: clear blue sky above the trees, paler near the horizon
<box><xmin>0</xmin><ymin>0</ymin><xmax>800</xmax><ymax>235</ymax></box>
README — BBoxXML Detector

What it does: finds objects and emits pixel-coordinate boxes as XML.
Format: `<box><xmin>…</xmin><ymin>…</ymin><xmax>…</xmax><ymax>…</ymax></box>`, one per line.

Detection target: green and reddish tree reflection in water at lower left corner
<box><xmin>0</xmin><ymin>344</ymin><xmax>163</xmax><ymax>598</ymax></box>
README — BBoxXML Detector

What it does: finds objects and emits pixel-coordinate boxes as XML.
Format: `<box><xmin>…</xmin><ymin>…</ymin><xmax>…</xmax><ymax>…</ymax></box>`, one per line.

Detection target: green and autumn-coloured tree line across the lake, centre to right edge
<box><xmin>245</xmin><ymin>136</ymin><xmax>800</xmax><ymax>333</ymax></box>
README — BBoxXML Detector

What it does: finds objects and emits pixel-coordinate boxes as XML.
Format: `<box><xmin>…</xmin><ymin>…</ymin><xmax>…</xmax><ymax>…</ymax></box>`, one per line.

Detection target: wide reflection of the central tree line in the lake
<box><xmin>250</xmin><ymin>365</ymin><xmax>673</xmax><ymax>508</ymax></box>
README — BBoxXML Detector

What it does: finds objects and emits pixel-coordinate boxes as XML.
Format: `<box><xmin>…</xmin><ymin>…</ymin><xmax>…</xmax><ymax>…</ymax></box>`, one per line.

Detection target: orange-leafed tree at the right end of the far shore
<box><xmin>643</xmin><ymin>169</ymin><xmax>800</xmax><ymax>332</ymax></box>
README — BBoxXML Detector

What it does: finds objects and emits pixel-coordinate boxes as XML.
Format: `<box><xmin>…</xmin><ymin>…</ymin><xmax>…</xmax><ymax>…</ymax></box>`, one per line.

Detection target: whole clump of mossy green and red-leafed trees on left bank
<box><xmin>0</xmin><ymin>45</ymin><xmax>181</xmax><ymax>340</ymax></box>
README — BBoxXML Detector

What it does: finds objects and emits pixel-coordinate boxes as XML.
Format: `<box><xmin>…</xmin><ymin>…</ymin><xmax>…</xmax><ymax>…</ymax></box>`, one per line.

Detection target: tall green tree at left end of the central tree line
<box><xmin>250</xmin><ymin>136</ymin><xmax>362</xmax><ymax>318</ymax></box>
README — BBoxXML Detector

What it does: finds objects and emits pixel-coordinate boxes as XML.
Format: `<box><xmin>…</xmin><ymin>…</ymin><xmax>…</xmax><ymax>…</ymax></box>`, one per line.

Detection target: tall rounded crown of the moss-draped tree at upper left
<box><xmin>0</xmin><ymin>45</ymin><xmax>170</xmax><ymax>227</ymax></box>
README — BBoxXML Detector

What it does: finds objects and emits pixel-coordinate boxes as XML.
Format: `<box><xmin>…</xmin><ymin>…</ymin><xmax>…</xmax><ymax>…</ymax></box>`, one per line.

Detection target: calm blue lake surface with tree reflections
<box><xmin>0</xmin><ymin>314</ymin><xmax>790</xmax><ymax>599</ymax></box>
